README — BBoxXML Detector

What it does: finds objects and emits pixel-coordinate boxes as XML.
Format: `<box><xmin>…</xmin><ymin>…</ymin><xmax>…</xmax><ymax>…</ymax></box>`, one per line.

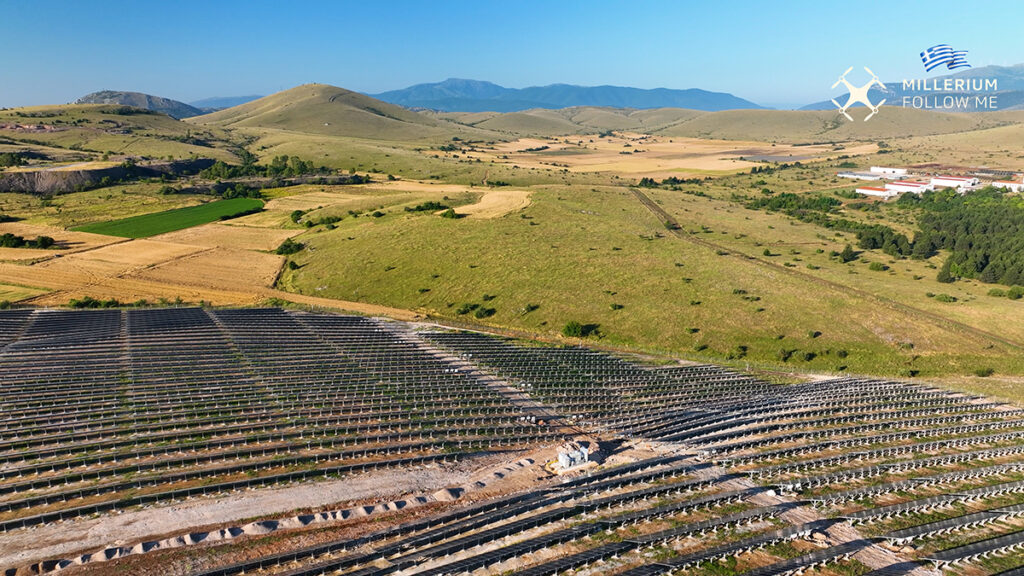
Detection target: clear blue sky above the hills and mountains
<box><xmin>0</xmin><ymin>0</ymin><xmax>1024</xmax><ymax>107</ymax></box>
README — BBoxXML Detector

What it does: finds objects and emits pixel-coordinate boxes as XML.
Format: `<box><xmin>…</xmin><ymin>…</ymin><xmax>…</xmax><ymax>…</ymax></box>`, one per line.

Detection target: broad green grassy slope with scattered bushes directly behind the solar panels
<box><xmin>281</xmin><ymin>187</ymin><xmax>1022</xmax><ymax>375</ymax></box>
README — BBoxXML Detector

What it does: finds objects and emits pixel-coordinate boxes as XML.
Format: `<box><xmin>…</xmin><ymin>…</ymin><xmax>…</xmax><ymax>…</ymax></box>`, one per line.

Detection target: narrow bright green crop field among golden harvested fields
<box><xmin>73</xmin><ymin>198</ymin><xmax>263</xmax><ymax>238</ymax></box>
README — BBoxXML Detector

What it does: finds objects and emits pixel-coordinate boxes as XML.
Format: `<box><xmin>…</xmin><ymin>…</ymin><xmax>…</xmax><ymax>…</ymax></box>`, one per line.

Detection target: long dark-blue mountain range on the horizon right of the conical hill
<box><xmin>371</xmin><ymin>78</ymin><xmax>763</xmax><ymax>112</ymax></box>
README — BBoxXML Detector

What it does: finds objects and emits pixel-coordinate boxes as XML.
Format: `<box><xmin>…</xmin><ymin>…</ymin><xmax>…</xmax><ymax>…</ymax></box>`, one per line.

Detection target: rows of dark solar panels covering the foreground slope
<box><xmin>0</xmin><ymin>308</ymin><xmax>1024</xmax><ymax>576</ymax></box>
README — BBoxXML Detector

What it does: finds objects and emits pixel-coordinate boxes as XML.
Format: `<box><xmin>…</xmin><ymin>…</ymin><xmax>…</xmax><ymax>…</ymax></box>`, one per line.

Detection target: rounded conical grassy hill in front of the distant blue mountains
<box><xmin>189</xmin><ymin>84</ymin><xmax>493</xmax><ymax>141</ymax></box>
